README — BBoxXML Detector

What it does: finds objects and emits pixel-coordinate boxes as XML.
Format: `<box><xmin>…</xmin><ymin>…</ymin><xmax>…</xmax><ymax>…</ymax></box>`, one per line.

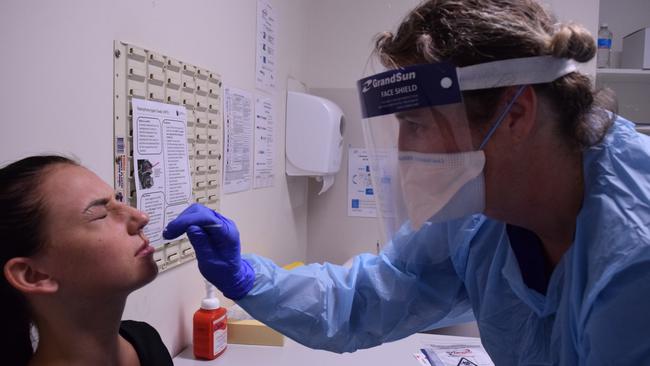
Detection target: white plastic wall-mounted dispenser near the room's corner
<box><xmin>286</xmin><ymin>91</ymin><xmax>345</xmax><ymax>194</ymax></box>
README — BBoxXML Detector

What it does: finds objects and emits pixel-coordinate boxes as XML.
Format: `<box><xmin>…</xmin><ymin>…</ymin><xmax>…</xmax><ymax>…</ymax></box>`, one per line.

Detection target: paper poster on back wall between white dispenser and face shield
<box><xmin>348</xmin><ymin>147</ymin><xmax>377</xmax><ymax>217</ymax></box>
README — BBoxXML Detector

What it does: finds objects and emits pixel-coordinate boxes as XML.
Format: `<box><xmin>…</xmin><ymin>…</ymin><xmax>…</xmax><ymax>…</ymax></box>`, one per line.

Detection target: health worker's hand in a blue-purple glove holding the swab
<box><xmin>163</xmin><ymin>204</ymin><xmax>255</xmax><ymax>300</ymax></box>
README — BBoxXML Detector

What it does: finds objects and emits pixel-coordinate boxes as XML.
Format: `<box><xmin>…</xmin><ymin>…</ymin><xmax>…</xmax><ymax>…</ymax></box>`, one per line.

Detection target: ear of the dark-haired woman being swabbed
<box><xmin>4</xmin><ymin>257</ymin><xmax>59</xmax><ymax>294</ymax></box>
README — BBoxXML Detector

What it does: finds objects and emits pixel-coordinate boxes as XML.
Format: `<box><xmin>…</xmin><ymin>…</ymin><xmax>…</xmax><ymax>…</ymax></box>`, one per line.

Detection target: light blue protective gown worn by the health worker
<box><xmin>238</xmin><ymin>118</ymin><xmax>650</xmax><ymax>366</ymax></box>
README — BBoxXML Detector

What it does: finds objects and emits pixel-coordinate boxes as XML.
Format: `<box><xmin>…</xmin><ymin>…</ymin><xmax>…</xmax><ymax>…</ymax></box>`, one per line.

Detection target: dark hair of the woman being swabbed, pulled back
<box><xmin>0</xmin><ymin>155</ymin><xmax>78</xmax><ymax>365</ymax></box>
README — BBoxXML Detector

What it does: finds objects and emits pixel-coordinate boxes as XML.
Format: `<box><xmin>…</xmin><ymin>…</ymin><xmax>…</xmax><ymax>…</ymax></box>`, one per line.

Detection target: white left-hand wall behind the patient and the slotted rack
<box><xmin>0</xmin><ymin>0</ymin><xmax>307</xmax><ymax>354</ymax></box>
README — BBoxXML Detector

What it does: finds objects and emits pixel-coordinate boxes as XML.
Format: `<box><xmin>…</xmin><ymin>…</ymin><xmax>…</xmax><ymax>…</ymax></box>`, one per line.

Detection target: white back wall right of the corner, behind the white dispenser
<box><xmin>303</xmin><ymin>0</ymin><xmax>419</xmax><ymax>264</ymax></box>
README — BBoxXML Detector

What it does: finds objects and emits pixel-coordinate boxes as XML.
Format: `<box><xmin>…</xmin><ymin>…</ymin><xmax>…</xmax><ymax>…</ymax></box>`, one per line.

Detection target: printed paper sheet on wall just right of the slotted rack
<box><xmin>223</xmin><ymin>87</ymin><xmax>253</xmax><ymax>193</ymax></box>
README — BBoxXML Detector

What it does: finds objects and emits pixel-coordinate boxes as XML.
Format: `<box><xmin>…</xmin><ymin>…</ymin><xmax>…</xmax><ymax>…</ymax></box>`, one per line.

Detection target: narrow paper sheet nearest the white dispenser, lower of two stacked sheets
<box><xmin>253</xmin><ymin>96</ymin><xmax>275</xmax><ymax>188</ymax></box>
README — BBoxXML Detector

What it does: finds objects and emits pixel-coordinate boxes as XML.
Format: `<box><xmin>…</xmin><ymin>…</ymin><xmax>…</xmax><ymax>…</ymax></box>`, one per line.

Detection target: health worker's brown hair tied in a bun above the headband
<box><xmin>375</xmin><ymin>0</ymin><xmax>616</xmax><ymax>148</ymax></box>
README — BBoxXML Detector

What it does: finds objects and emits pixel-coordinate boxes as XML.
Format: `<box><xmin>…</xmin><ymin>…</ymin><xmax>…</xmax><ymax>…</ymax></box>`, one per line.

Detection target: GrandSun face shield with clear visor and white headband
<box><xmin>357</xmin><ymin>56</ymin><xmax>577</xmax><ymax>241</ymax></box>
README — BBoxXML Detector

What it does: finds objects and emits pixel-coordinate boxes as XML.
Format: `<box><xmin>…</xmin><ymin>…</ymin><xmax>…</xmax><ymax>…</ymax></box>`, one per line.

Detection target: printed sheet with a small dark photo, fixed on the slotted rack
<box><xmin>132</xmin><ymin>98</ymin><xmax>192</xmax><ymax>247</ymax></box>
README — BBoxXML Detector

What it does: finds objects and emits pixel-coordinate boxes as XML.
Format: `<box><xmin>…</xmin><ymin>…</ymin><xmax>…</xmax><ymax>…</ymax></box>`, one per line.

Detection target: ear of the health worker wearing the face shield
<box><xmin>504</xmin><ymin>86</ymin><xmax>537</xmax><ymax>144</ymax></box>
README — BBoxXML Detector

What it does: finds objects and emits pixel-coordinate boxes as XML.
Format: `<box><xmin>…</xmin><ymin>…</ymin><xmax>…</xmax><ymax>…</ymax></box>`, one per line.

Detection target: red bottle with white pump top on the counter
<box><xmin>192</xmin><ymin>281</ymin><xmax>228</xmax><ymax>360</ymax></box>
